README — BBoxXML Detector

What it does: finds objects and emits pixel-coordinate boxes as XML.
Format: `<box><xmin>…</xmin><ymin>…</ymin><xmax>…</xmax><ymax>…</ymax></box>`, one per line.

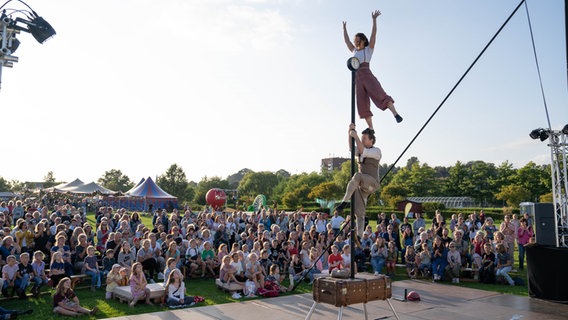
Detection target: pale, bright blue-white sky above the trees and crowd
<box><xmin>0</xmin><ymin>0</ymin><xmax>568</xmax><ymax>182</ymax></box>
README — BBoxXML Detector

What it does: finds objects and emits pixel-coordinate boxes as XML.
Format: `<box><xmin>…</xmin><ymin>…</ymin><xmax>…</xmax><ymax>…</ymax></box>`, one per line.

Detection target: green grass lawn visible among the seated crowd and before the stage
<box><xmin>0</xmin><ymin>215</ymin><xmax>528</xmax><ymax>320</ymax></box>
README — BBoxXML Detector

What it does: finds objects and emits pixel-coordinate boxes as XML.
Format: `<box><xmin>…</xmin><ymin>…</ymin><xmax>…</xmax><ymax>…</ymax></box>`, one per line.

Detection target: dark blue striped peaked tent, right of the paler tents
<box><xmin>105</xmin><ymin>177</ymin><xmax>177</xmax><ymax>211</ymax></box>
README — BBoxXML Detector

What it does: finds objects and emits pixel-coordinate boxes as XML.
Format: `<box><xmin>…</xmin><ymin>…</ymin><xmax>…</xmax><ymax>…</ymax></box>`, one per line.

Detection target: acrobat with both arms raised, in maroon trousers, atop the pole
<box><xmin>343</xmin><ymin>10</ymin><xmax>402</xmax><ymax>133</ymax></box>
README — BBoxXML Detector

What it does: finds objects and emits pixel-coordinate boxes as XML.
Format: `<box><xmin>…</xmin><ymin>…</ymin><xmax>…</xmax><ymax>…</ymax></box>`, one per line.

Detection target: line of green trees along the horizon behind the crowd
<box><xmin>0</xmin><ymin>157</ymin><xmax>552</xmax><ymax>209</ymax></box>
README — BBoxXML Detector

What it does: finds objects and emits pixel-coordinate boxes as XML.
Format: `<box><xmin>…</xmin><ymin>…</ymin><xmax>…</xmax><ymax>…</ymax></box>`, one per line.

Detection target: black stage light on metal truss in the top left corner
<box><xmin>0</xmin><ymin>0</ymin><xmax>55</xmax><ymax>90</ymax></box>
